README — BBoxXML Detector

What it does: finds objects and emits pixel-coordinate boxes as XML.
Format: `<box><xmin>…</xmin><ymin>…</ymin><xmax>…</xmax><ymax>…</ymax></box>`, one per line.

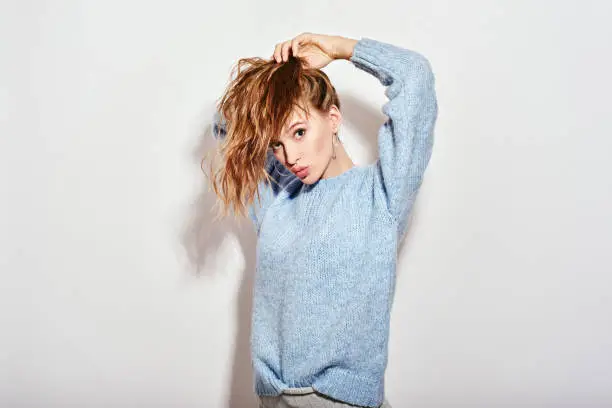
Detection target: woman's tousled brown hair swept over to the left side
<box><xmin>204</xmin><ymin>55</ymin><xmax>340</xmax><ymax>222</ymax></box>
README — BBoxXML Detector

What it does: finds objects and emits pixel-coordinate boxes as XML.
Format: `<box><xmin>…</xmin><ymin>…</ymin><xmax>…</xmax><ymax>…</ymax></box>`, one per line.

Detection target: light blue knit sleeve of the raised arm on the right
<box><xmin>350</xmin><ymin>37</ymin><xmax>438</xmax><ymax>230</ymax></box>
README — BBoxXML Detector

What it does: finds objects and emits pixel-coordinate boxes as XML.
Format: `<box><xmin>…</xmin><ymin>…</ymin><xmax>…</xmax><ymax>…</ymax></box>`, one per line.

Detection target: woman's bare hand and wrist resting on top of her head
<box><xmin>271</xmin><ymin>32</ymin><xmax>357</xmax><ymax>69</ymax></box>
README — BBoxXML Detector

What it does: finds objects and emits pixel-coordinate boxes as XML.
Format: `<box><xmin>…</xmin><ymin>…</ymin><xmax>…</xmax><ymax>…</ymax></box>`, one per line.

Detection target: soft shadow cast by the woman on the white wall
<box><xmin>181</xmin><ymin>90</ymin><xmax>424</xmax><ymax>408</ymax></box>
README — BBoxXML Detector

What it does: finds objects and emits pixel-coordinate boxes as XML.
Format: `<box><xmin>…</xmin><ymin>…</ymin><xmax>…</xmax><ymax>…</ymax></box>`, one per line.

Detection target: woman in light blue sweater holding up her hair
<box><xmin>208</xmin><ymin>33</ymin><xmax>438</xmax><ymax>408</ymax></box>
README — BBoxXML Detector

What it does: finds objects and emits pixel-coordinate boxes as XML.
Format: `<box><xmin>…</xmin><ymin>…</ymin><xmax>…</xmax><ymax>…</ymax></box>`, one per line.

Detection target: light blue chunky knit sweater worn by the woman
<box><xmin>213</xmin><ymin>37</ymin><xmax>438</xmax><ymax>407</ymax></box>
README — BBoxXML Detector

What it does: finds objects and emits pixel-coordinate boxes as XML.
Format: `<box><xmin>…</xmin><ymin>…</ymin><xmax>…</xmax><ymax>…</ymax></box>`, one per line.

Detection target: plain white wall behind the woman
<box><xmin>0</xmin><ymin>0</ymin><xmax>612</xmax><ymax>408</ymax></box>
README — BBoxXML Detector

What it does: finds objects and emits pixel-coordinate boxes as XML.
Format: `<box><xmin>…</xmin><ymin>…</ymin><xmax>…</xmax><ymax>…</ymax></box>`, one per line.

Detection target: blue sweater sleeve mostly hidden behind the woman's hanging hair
<box><xmin>212</xmin><ymin>111</ymin><xmax>302</xmax><ymax>235</ymax></box>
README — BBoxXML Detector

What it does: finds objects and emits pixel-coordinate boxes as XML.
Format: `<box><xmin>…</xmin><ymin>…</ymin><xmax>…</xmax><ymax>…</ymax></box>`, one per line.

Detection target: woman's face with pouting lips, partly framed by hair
<box><xmin>270</xmin><ymin>105</ymin><xmax>342</xmax><ymax>184</ymax></box>
